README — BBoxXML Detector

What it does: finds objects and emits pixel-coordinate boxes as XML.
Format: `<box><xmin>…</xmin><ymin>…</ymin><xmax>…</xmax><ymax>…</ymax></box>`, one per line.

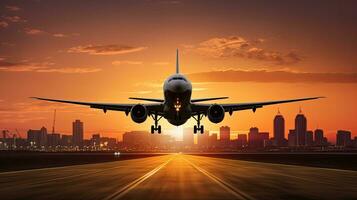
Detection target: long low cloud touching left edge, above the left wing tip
<box><xmin>0</xmin><ymin>59</ymin><xmax>102</xmax><ymax>74</ymax></box>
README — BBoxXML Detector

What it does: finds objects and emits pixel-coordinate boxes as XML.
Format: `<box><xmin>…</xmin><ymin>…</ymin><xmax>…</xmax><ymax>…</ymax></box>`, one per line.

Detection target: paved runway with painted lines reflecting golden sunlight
<box><xmin>0</xmin><ymin>154</ymin><xmax>357</xmax><ymax>200</ymax></box>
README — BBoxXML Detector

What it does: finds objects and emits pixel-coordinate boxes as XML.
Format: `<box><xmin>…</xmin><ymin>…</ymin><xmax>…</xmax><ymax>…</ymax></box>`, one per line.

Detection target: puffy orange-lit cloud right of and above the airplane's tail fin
<box><xmin>188</xmin><ymin>36</ymin><xmax>302</xmax><ymax>65</ymax></box>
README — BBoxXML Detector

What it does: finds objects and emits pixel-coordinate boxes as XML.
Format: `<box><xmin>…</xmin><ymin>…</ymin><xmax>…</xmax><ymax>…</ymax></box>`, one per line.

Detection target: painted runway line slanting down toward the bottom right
<box><xmin>183</xmin><ymin>158</ymin><xmax>255</xmax><ymax>200</ymax></box>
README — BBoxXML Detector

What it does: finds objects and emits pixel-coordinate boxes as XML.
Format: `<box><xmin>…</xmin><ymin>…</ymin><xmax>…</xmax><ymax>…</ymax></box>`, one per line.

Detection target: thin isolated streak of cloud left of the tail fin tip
<box><xmin>68</xmin><ymin>44</ymin><xmax>147</xmax><ymax>55</ymax></box>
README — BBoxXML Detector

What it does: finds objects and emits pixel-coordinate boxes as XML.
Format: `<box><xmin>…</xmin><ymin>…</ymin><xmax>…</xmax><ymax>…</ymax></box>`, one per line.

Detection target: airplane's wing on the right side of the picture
<box><xmin>192</xmin><ymin>97</ymin><xmax>324</xmax><ymax>115</ymax></box>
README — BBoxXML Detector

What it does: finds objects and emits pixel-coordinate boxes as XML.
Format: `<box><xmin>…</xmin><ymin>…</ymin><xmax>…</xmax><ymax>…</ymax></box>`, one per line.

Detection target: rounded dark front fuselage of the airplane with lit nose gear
<box><xmin>163</xmin><ymin>74</ymin><xmax>192</xmax><ymax>126</ymax></box>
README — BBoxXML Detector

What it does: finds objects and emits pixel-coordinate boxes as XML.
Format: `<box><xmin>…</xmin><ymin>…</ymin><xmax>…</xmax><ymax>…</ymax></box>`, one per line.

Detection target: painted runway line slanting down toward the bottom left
<box><xmin>103</xmin><ymin>157</ymin><xmax>174</xmax><ymax>200</ymax></box>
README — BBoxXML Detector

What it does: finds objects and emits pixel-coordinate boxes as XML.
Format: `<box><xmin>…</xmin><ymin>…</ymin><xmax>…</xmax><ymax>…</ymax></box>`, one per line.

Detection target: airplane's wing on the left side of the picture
<box><xmin>30</xmin><ymin>97</ymin><xmax>163</xmax><ymax>115</ymax></box>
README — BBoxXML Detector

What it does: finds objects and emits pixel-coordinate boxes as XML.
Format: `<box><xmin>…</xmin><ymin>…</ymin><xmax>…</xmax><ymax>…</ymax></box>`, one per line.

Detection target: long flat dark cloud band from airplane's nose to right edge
<box><xmin>188</xmin><ymin>70</ymin><xmax>357</xmax><ymax>83</ymax></box>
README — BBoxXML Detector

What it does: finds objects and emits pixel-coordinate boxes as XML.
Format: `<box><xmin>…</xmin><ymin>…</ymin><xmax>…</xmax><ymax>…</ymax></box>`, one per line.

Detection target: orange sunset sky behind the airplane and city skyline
<box><xmin>0</xmin><ymin>0</ymin><xmax>357</xmax><ymax>140</ymax></box>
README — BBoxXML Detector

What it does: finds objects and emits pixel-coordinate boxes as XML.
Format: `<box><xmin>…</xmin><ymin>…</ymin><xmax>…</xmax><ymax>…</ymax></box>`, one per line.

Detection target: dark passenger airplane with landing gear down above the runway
<box><xmin>30</xmin><ymin>49</ymin><xmax>323</xmax><ymax>134</ymax></box>
